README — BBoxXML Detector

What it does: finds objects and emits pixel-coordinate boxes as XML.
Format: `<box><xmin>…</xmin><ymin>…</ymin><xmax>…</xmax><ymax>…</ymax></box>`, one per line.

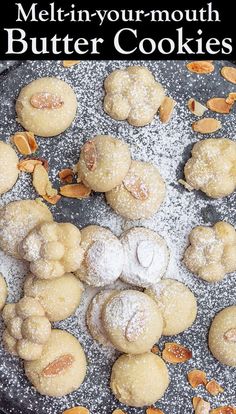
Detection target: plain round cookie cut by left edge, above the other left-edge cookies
<box><xmin>0</xmin><ymin>141</ymin><xmax>19</xmax><ymax>195</ymax></box>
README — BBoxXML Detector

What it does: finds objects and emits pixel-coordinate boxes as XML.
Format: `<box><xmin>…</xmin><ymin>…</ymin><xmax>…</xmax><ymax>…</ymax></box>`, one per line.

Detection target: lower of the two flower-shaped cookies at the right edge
<box><xmin>184</xmin><ymin>221</ymin><xmax>236</xmax><ymax>282</ymax></box>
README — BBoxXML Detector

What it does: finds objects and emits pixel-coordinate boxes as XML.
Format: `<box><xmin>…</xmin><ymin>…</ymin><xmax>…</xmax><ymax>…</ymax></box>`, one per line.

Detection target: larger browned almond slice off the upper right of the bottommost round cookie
<box><xmin>162</xmin><ymin>342</ymin><xmax>192</xmax><ymax>364</ymax></box>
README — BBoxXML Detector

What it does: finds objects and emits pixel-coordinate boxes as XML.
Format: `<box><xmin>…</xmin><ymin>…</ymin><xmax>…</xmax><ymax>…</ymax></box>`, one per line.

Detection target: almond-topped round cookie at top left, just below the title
<box><xmin>16</xmin><ymin>77</ymin><xmax>77</xmax><ymax>137</ymax></box>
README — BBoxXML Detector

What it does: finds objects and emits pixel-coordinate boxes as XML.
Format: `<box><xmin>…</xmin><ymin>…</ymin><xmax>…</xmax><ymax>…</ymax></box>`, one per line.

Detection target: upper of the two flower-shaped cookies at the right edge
<box><xmin>184</xmin><ymin>138</ymin><xmax>236</xmax><ymax>198</ymax></box>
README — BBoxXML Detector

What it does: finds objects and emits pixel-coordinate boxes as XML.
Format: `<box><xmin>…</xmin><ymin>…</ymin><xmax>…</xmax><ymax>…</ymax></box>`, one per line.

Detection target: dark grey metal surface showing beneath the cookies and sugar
<box><xmin>0</xmin><ymin>61</ymin><xmax>236</xmax><ymax>414</ymax></box>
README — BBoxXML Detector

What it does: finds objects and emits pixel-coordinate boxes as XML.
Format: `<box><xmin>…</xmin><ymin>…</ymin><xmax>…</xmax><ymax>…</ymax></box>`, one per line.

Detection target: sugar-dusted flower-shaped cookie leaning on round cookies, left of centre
<box><xmin>19</xmin><ymin>222</ymin><xmax>83</xmax><ymax>279</ymax></box>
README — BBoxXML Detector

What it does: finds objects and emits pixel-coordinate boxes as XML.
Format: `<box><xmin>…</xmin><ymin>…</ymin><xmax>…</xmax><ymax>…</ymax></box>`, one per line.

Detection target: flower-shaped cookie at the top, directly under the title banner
<box><xmin>104</xmin><ymin>66</ymin><xmax>165</xmax><ymax>126</ymax></box>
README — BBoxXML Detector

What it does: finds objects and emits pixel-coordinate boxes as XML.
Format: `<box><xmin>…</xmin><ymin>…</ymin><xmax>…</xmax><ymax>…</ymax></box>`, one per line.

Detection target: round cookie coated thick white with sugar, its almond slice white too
<box><xmin>120</xmin><ymin>227</ymin><xmax>169</xmax><ymax>287</ymax></box>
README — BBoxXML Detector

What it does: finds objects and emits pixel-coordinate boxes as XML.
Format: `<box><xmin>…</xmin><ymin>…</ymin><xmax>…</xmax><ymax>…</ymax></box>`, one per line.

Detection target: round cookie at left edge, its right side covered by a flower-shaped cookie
<box><xmin>0</xmin><ymin>200</ymin><xmax>53</xmax><ymax>259</ymax></box>
